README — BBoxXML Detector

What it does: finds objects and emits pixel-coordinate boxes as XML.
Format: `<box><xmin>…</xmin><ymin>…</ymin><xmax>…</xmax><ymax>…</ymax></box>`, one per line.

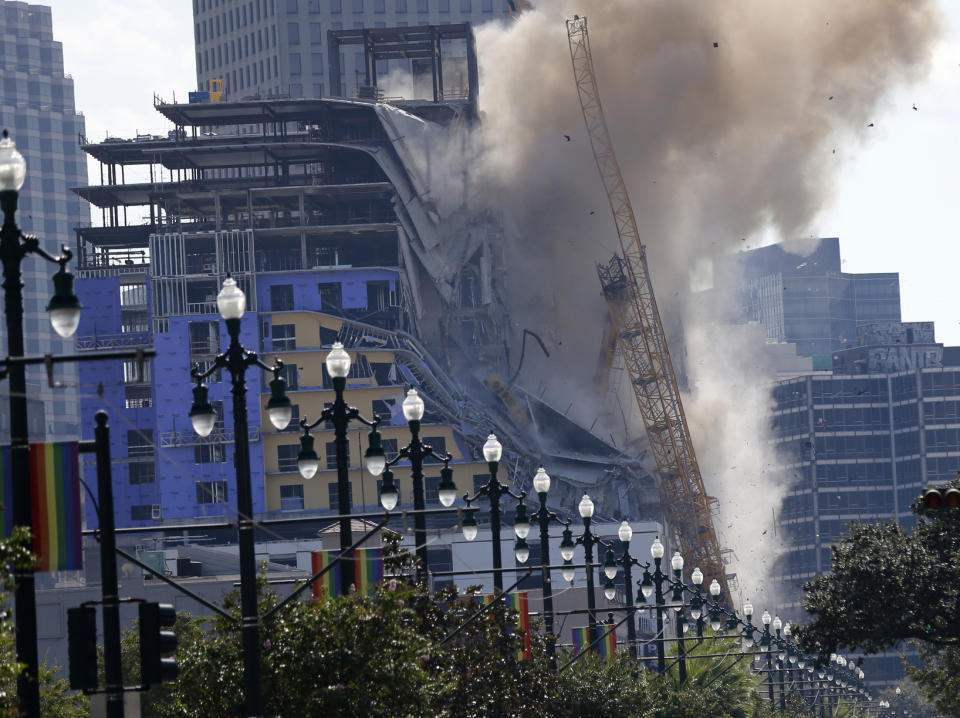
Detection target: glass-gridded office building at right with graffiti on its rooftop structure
<box><xmin>773</xmin><ymin>322</ymin><xmax>960</xmax><ymax>681</ymax></box>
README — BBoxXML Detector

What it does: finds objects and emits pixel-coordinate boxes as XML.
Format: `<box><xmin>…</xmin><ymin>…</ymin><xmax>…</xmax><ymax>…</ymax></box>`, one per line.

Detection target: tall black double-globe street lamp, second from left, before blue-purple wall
<box><xmin>190</xmin><ymin>276</ymin><xmax>293</xmax><ymax>716</ymax></box>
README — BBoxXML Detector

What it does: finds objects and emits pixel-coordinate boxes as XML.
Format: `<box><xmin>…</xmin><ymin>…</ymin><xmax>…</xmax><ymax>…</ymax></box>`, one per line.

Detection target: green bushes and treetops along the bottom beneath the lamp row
<box><xmin>124</xmin><ymin>540</ymin><xmax>844</xmax><ymax>718</ymax></box>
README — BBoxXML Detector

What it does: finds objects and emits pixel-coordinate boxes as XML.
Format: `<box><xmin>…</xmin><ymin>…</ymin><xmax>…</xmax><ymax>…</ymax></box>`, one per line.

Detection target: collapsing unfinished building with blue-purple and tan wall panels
<box><xmin>76</xmin><ymin>25</ymin><xmax>659</xmax><ymax>548</ymax></box>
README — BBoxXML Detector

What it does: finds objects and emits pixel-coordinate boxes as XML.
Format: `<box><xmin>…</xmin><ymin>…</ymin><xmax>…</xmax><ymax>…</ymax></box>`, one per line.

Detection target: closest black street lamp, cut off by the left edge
<box><xmin>0</xmin><ymin>130</ymin><xmax>81</xmax><ymax>718</ymax></box>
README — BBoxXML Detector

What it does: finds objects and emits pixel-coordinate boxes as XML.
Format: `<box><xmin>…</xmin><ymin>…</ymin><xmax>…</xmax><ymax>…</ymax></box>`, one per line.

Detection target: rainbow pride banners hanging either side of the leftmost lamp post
<box><xmin>0</xmin><ymin>441</ymin><xmax>83</xmax><ymax>571</ymax></box>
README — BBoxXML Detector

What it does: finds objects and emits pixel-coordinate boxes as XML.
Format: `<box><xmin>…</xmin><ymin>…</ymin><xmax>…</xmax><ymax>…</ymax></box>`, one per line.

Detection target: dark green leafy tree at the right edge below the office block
<box><xmin>796</xmin><ymin>479</ymin><xmax>960</xmax><ymax>716</ymax></box>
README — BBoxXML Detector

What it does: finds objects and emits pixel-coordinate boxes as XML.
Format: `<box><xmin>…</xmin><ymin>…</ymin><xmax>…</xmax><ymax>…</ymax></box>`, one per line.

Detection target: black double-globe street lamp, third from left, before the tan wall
<box><xmin>297</xmin><ymin>342</ymin><xmax>386</xmax><ymax>587</ymax></box>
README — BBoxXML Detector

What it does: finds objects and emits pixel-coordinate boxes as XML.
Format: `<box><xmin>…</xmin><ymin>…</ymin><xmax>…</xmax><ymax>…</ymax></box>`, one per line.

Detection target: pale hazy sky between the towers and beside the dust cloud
<box><xmin>35</xmin><ymin>0</ymin><xmax>960</xmax><ymax>344</ymax></box>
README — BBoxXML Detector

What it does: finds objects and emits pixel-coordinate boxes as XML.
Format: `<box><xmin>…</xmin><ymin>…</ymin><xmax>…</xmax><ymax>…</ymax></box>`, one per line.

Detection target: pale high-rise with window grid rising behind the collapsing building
<box><xmin>193</xmin><ymin>0</ymin><xmax>509</xmax><ymax>100</ymax></box>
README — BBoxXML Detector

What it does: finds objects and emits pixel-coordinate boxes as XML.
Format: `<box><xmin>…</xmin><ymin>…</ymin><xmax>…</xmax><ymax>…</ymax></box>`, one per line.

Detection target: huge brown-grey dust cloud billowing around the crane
<box><xmin>464</xmin><ymin>0</ymin><xmax>940</xmax><ymax>597</ymax></box>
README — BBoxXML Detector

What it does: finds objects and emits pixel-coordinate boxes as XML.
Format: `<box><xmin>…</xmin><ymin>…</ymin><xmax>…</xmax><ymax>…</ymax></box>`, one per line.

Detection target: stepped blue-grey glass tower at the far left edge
<box><xmin>0</xmin><ymin>0</ymin><xmax>89</xmax><ymax>441</ymax></box>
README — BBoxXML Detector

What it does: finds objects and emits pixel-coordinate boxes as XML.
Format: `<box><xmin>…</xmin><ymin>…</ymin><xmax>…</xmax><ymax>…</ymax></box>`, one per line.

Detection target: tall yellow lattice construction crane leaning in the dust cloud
<box><xmin>567</xmin><ymin>15</ymin><xmax>731</xmax><ymax>601</ymax></box>
